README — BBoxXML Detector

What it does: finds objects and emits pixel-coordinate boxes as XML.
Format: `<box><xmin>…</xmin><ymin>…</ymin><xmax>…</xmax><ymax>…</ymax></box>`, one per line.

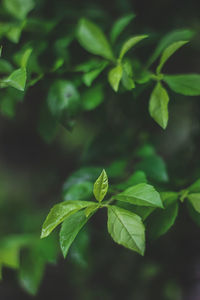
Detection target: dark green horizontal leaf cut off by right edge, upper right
<box><xmin>163</xmin><ymin>74</ymin><xmax>200</xmax><ymax>96</ymax></box>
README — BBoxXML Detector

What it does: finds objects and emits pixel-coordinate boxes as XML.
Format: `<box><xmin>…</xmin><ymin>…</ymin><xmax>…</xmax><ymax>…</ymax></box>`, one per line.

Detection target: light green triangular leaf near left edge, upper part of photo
<box><xmin>3</xmin><ymin>68</ymin><xmax>26</xmax><ymax>91</ymax></box>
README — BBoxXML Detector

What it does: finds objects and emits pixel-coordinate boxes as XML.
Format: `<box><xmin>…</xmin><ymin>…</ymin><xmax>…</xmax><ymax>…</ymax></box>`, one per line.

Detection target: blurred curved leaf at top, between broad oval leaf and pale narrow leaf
<box><xmin>110</xmin><ymin>14</ymin><xmax>135</xmax><ymax>44</ymax></box>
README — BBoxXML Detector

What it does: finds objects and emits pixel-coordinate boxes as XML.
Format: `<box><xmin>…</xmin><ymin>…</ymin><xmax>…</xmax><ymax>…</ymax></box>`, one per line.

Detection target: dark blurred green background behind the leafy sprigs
<box><xmin>0</xmin><ymin>0</ymin><xmax>200</xmax><ymax>300</ymax></box>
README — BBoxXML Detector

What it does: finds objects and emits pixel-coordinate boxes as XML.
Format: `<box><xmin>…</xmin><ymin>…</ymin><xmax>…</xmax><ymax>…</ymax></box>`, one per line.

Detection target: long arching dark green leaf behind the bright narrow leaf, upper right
<box><xmin>147</xmin><ymin>29</ymin><xmax>195</xmax><ymax>67</ymax></box>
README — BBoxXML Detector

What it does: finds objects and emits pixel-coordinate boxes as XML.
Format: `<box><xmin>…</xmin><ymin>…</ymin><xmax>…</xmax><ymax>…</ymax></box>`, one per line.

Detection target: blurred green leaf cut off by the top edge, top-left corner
<box><xmin>3</xmin><ymin>0</ymin><xmax>35</xmax><ymax>19</ymax></box>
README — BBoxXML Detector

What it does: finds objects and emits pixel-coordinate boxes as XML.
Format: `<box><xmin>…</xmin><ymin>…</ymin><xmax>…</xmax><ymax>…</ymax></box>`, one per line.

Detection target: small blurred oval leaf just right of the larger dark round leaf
<box><xmin>81</xmin><ymin>84</ymin><xmax>104</xmax><ymax>110</ymax></box>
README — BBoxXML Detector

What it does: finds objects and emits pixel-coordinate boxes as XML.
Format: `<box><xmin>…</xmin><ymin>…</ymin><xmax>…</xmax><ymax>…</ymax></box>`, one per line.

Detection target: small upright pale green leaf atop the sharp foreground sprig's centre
<box><xmin>93</xmin><ymin>170</ymin><xmax>108</xmax><ymax>202</ymax></box>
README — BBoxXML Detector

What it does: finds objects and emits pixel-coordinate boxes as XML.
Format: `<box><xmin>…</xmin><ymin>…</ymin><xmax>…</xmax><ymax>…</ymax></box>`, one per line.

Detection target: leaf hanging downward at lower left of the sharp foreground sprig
<box><xmin>60</xmin><ymin>210</ymin><xmax>90</xmax><ymax>258</ymax></box>
